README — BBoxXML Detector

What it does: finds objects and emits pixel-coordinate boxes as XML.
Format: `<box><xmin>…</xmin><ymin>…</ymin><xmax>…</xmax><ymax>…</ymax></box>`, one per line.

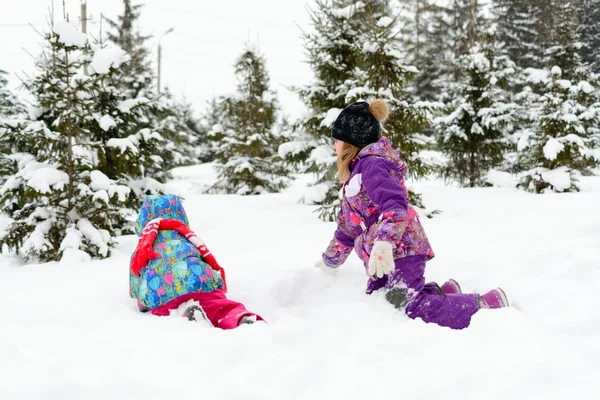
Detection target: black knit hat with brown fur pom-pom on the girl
<box><xmin>331</xmin><ymin>100</ymin><xmax>388</xmax><ymax>148</ymax></box>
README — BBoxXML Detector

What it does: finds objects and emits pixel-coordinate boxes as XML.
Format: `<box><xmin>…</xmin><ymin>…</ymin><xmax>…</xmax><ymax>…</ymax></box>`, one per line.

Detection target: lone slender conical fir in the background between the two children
<box><xmin>212</xmin><ymin>48</ymin><xmax>286</xmax><ymax>195</ymax></box>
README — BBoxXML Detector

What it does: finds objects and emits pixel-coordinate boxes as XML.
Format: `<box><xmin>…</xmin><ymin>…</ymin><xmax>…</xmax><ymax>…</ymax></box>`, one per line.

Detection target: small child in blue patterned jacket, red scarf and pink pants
<box><xmin>129</xmin><ymin>195</ymin><xmax>262</xmax><ymax>329</ymax></box>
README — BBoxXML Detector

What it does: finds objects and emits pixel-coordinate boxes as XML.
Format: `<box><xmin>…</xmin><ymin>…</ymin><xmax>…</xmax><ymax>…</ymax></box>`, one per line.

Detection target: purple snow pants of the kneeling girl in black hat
<box><xmin>367</xmin><ymin>256</ymin><xmax>479</xmax><ymax>329</ymax></box>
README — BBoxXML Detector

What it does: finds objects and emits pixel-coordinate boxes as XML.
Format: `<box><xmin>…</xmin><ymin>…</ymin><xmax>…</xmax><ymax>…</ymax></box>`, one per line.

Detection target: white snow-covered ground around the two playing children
<box><xmin>0</xmin><ymin>166</ymin><xmax>600</xmax><ymax>400</ymax></box>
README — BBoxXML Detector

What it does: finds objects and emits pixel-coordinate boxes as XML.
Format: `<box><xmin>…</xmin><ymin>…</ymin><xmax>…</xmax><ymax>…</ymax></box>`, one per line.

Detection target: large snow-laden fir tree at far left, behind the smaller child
<box><xmin>0</xmin><ymin>22</ymin><xmax>130</xmax><ymax>262</ymax></box>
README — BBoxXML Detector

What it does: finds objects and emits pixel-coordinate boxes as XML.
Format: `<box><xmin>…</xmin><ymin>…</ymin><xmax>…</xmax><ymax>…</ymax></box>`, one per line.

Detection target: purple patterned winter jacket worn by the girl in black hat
<box><xmin>323</xmin><ymin>136</ymin><xmax>434</xmax><ymax>268</ymax></box>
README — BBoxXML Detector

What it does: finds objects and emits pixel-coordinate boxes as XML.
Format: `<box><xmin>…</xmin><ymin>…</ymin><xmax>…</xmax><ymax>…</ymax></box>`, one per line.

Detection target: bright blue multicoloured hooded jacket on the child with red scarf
<box><xmin>129</xmin><ymin>195</ymin><xmax>223</xmax><ymax>311</ymax></box>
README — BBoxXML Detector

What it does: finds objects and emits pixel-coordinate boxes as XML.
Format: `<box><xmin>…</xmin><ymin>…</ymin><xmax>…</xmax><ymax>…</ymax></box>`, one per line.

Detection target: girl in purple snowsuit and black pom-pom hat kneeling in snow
<box><xmin>317</xmin><ymin>100</ymin><xmax>508</xmax><ymax>329</ymax></box>
